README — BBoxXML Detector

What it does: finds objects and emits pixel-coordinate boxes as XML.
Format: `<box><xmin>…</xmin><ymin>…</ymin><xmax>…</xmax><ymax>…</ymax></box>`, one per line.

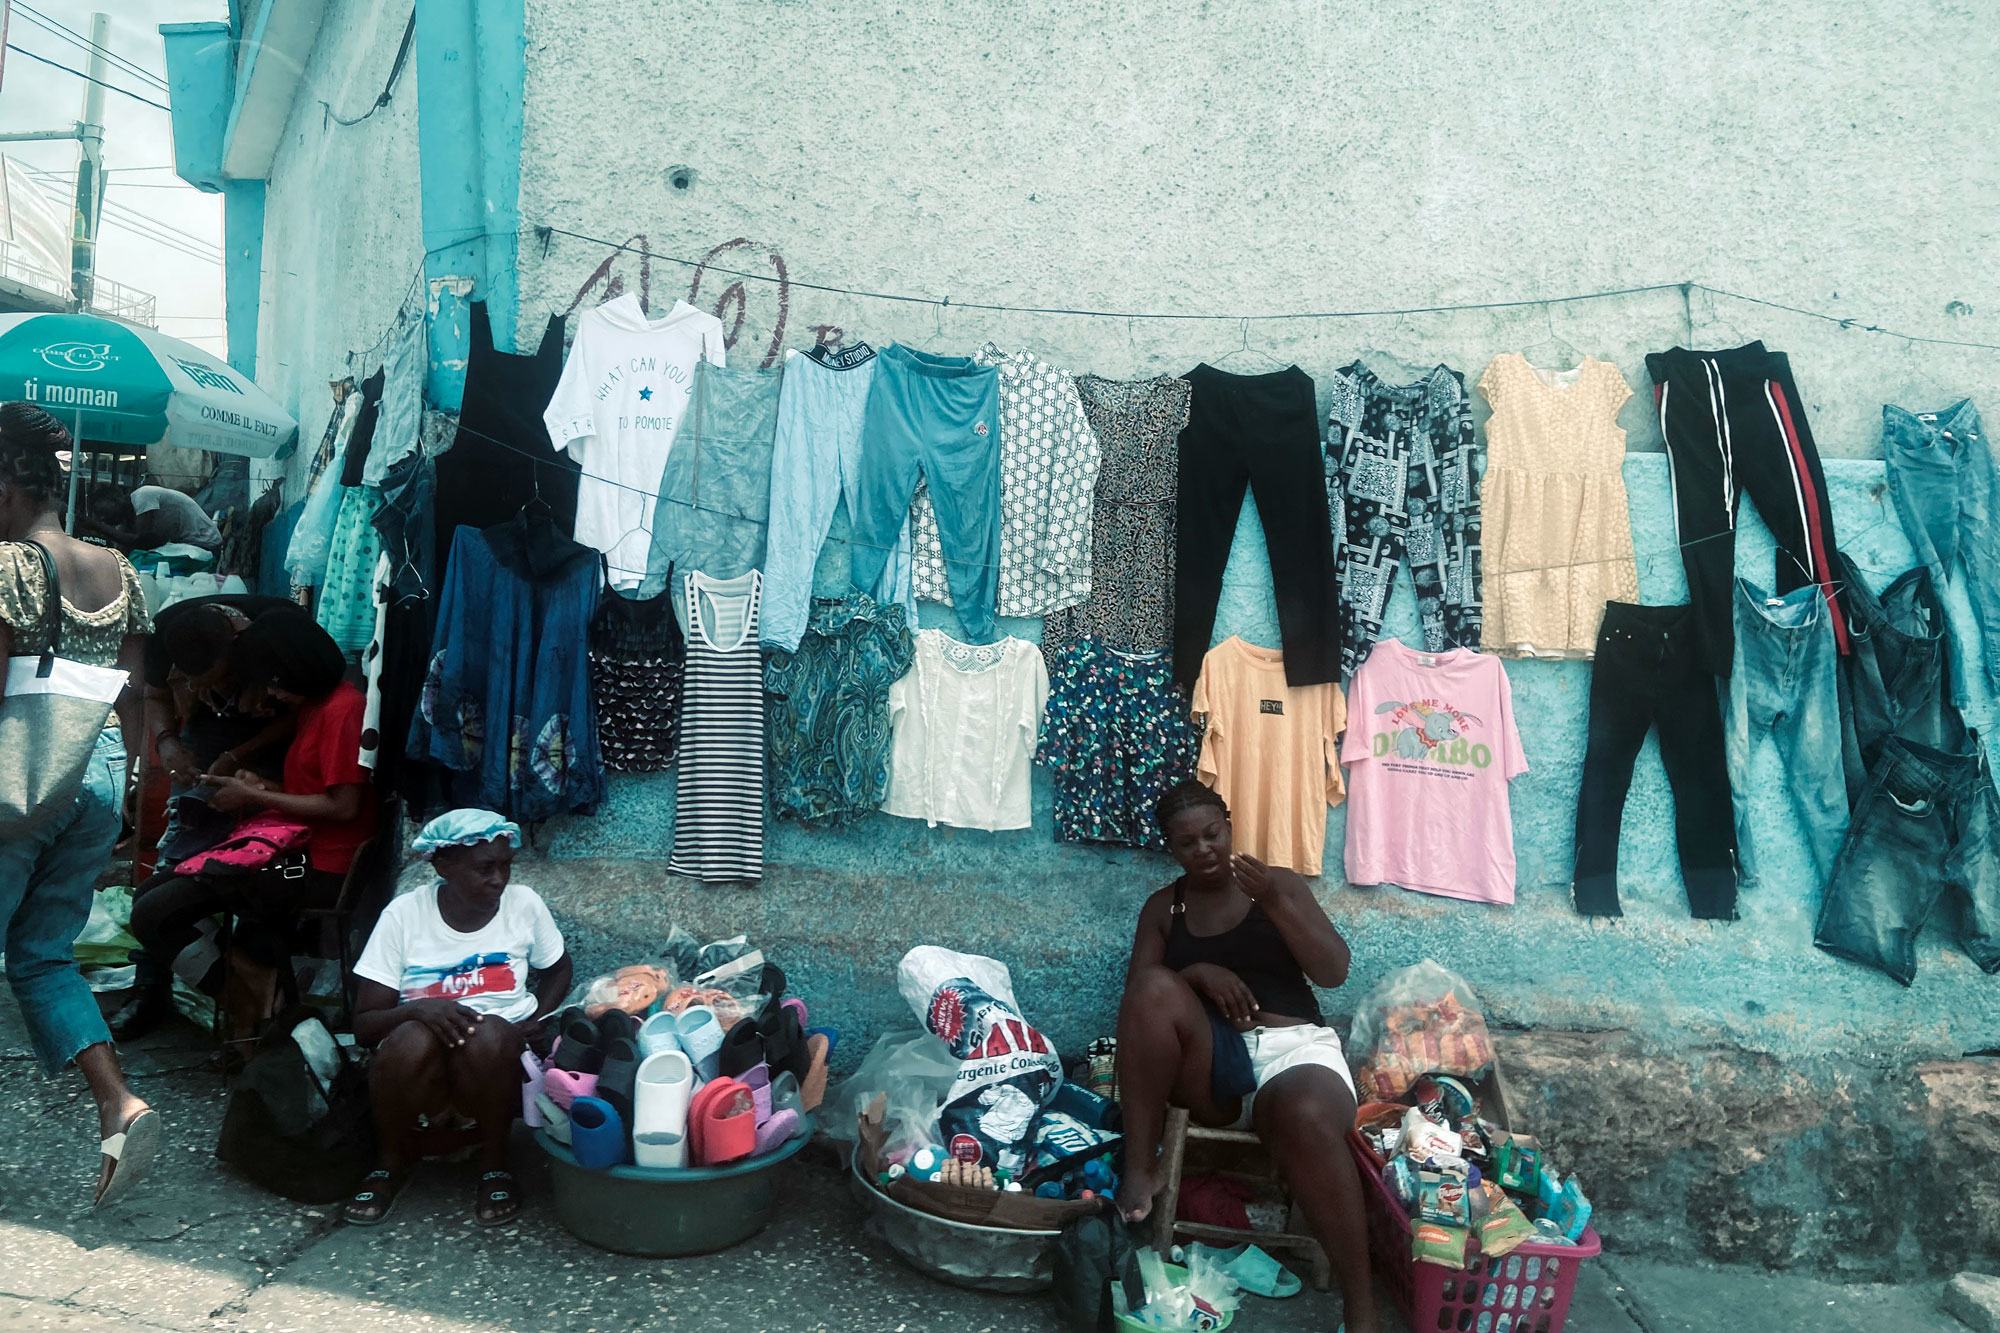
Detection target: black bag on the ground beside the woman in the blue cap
<box><xmin>216</xmin><ymin>1007</ymin><xmax>374</xmax><ymax>1203</ymax></box>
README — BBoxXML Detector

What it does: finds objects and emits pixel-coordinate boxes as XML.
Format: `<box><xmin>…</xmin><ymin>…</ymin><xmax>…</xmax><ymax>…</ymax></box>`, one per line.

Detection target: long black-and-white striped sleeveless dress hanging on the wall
<box><xmin>666</xmin><ymin>570</ymin><xmax>764</xmax><ymax>881</ymax></box>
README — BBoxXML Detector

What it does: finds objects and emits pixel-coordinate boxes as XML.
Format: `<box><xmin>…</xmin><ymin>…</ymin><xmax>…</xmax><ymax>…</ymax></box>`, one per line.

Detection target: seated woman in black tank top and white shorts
<box><xmin>1118</xmin><ymin>779</ymin><xmax>1380</xmax><ymax>1333</ymax></box>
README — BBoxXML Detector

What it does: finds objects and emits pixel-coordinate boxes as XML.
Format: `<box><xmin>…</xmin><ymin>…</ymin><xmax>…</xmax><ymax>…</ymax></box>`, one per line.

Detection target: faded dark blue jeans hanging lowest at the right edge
<box><xmin>1812</xmin><ymin>737</ymin><xmax>2000</xmax><ymax>985</ymax></box>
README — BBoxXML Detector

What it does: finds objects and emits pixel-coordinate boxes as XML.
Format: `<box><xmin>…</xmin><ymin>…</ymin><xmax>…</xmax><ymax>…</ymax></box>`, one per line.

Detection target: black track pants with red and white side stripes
<box><xmin>1646</xmin><ymin>342</ymin><xmax>1848</xmax><ymax>677</ymax></box>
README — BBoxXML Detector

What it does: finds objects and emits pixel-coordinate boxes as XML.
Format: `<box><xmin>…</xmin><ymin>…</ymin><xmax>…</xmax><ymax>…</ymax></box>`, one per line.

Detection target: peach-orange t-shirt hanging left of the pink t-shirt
<box><xmin>1194</xmin><ymin>634</ymin><xmax>1348</xmax><ymax>875</ymax></box>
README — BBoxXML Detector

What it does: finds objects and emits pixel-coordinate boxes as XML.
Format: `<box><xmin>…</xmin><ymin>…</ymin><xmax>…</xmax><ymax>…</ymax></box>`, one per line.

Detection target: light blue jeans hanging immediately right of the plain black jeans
<box><xmin>1726</xmin><ymin>578</ymin><xmax>1848</xmax><ymax>889</ymax></box>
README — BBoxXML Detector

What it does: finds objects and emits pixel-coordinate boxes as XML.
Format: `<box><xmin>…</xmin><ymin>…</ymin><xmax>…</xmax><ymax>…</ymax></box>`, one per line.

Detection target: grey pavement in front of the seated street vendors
<box><xmin>0</xmin><ymin>999</ymin><xmax>1962</xmax><ymax>1333</ymax></box>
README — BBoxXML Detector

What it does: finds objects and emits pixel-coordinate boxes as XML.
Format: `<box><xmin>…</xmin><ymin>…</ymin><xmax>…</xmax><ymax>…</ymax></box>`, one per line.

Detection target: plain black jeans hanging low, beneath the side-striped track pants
<box><xmin>1576</xmin><ymin>602</ymin><xmax>1736</xmax><ymax>921</ymax></box>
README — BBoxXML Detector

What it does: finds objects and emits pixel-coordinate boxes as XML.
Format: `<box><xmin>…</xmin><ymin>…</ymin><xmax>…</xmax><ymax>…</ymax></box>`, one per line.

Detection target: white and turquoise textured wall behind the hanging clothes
<box><xmin>496</xmin><ymin>0</ymin><xmax>2000</xmax><ymax>1273</ymax></box>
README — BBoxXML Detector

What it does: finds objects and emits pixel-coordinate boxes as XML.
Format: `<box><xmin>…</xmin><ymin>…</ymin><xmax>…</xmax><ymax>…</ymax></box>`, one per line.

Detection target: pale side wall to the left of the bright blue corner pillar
<box><xmin>254</xmin><ymin>0</ymin><xmax>424</xmax><ymax>490</ymax></box>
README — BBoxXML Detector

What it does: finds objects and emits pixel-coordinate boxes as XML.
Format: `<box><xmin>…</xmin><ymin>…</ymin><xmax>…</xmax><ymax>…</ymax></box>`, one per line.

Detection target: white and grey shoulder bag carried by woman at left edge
<box><xmin>0</xmin><ymin>542</ymin><xmax>126</xmax><ymax>839</ymax></box>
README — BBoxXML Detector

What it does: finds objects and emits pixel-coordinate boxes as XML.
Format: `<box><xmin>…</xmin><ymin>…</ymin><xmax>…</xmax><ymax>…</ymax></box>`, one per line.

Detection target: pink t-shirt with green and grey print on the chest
<box><xmin>1340</xmin><ymin>638</ymin><xmax>1528</xmax><ymax>903</ymax></box>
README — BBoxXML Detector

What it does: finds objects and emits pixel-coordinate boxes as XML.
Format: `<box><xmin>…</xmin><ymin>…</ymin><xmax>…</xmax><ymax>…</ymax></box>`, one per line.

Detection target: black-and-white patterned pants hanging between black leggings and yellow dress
<box><xmin>1326</xmin><ymin>362</ymin><xmax>1480</xmax><ymax>681</ymax></box>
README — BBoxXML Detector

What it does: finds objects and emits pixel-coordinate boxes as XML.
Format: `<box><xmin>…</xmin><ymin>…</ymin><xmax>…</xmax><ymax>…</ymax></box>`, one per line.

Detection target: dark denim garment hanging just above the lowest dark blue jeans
<box><xmin>1834</xmin><ymin>554</ymin><xmax>1966</xmax><ymax>809</ymax></box>
